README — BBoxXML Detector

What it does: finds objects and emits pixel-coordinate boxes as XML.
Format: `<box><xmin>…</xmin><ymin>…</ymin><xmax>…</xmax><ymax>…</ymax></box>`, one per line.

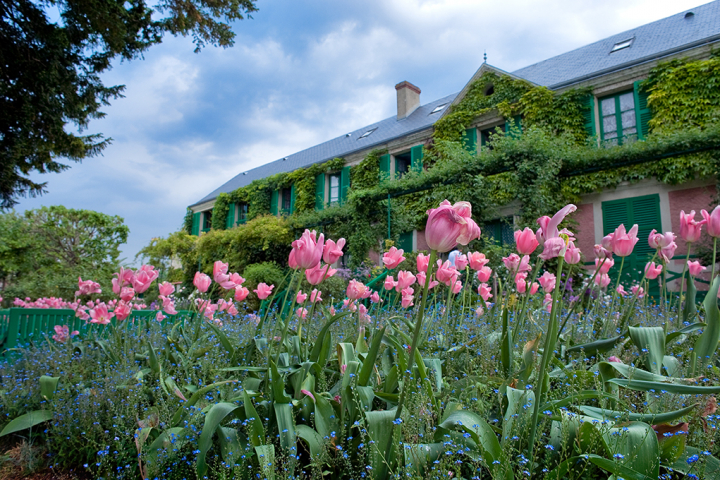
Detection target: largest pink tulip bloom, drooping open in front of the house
<box><xmin>425</xmin><ymin>200</ymin><xmax>480</xmax><ymax>252</ymax></box>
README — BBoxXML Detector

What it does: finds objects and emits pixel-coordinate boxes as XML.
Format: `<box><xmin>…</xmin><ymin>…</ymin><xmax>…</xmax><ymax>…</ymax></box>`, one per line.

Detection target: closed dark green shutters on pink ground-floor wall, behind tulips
<box><xmin>602</xmin><ymin>194</ymin><xmax>662</xmax><ymax>293</ymax></box>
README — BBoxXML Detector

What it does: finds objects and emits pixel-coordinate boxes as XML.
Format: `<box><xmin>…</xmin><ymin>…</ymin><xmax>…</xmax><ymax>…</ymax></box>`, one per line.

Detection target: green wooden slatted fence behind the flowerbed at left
<box><xmin>0</xmin><ymin>308</ymin><xmax>192</xmax><ymax>352</ymax></box>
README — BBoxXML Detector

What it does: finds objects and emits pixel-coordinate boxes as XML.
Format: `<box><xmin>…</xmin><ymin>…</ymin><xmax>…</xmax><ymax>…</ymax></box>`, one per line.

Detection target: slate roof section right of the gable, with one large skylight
<box><xmin>512</xmin><ymin>1</ymin><xmax>720</xmax><ymax>89</ymax></box>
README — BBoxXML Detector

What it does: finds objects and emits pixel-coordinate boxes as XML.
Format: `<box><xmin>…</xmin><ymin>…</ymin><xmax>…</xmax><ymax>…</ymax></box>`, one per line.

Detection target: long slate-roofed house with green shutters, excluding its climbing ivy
<box><xmin>189</xmin><ymin>1</ymin><xmax>720</xmax><ymax>286</ymax></box>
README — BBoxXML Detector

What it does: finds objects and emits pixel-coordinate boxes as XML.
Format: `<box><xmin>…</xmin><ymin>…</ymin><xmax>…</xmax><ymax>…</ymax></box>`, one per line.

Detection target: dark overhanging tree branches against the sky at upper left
<box><xmin>0</xmin><ymin>0</ymin><xmax>257</xmax><ymax>208</ymax></box>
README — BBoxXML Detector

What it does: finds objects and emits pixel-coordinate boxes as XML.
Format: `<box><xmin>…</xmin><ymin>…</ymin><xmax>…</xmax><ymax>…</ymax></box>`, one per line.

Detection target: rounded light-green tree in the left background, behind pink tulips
<box><xmin>0</xmin><ymin>206</ymin><xmax>129</xmax><ymax>303</ymax></box>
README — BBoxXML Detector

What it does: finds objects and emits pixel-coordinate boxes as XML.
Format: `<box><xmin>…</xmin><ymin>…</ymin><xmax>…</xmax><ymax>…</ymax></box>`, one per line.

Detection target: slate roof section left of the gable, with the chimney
<box><xmin>191</xmin><ymin>93</ymin><xmax>457</xmax><ymax>206</ymax></box>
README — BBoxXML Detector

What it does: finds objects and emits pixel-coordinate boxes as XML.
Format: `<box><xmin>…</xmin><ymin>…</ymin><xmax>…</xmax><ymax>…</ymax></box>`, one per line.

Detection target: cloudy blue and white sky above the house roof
<box><xmin>16</xmin><ymin>0</ymin><xmax>706</xmax><ymax>264</ymax></box>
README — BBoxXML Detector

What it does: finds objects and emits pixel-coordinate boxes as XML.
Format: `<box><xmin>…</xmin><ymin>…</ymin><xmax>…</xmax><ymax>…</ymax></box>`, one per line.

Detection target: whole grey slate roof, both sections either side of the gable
<box><xmin>192</xmin><ymin>0</ymin><xmax>720</xmax><ymax>206</ymax></box>
